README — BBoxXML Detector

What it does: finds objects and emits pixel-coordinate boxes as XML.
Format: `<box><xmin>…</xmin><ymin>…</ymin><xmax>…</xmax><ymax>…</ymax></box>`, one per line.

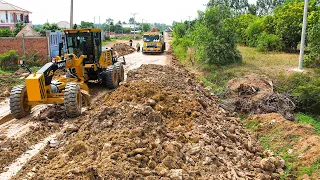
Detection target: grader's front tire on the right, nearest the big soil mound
<box><xmin>64</xmin><ymin>82</ymin><xmax>82</xmax><ymax>118</ymax></box>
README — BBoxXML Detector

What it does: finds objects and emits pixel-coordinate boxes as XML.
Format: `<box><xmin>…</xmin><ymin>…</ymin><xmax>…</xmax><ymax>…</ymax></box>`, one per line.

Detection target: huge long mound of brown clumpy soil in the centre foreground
<box><xmin>12</xmin><ymin>65</ymin><xmax>279</xmax><ymax>179</ymax></box>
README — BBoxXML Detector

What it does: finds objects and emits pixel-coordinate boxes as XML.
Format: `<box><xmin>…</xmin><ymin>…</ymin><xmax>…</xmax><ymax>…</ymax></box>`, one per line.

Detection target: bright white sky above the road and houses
<box><xmin>5</xmin><ymin>0</ymin><xmax>255</xmax><ymax>25</ymax></box>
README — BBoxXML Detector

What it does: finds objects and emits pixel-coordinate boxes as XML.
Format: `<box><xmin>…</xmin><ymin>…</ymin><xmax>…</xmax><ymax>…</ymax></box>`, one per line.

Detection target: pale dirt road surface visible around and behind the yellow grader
<box><xmin>0</xmin><ymin>33</ymin><xmax>172</xmax><ymax>180</ymax></box>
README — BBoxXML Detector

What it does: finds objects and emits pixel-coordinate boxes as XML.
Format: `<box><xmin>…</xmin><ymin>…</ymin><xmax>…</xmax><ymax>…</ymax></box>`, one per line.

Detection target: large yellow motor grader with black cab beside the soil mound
<box><xmin>10</xmin><ymin>28</ymin><xmax>125</xmax><ymax>119</ymax></box>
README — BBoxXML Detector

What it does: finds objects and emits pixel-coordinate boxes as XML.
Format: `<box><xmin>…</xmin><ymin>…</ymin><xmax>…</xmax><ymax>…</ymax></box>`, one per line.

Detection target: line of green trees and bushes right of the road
<box><xmin>173</xmin><ymin>0</ymin><xmax>320</xmax><ymax>67</ymax></box>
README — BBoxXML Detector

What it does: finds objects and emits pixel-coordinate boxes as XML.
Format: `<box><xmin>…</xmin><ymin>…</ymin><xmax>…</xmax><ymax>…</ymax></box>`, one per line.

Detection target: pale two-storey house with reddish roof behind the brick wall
<box><xmin>0</xmin><ymin>0</ymin><xmax>31</xmax><ymax>30</ymax></box>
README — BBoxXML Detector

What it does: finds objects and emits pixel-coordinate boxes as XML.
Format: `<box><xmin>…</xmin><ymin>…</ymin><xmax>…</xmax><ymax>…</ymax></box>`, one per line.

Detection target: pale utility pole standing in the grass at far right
<box><xmin>298</xmin><ymin>0</ymin><xmax>308</xmax><ymax>71</ymax></box>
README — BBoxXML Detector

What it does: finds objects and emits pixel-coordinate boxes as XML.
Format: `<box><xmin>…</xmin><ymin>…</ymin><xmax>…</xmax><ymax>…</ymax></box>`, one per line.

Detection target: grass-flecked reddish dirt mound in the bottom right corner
<box><xmin>246</xmin><ymin>113</ymin><xmax>320</xmax><ymax>179</ymax></box>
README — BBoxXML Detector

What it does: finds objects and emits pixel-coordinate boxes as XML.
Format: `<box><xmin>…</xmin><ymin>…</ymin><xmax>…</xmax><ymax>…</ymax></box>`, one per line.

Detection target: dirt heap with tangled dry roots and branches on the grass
<box><xmin>221</xmin><ymin>74</ymin><xmax>296</xmax><ymax>120</ymax></box>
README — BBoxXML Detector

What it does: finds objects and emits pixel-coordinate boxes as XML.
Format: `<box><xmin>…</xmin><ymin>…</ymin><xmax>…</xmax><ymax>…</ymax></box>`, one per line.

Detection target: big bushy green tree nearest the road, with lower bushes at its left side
<box><xmin>172</xmin><ymin>5</ymin><xmax>242</xmax><ymax>66</ymax></box>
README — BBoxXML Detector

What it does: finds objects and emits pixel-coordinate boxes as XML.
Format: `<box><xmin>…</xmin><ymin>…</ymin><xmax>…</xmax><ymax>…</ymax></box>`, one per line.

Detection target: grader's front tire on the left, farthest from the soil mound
<box><xmin>9</xmin><ymin>85</ymin><xmax>31</xmax><ymax>119</ymax></box>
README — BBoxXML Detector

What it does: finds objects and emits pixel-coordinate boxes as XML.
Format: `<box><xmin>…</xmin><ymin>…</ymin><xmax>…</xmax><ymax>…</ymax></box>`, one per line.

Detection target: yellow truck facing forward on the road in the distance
<box><xmin>142</xmin><ymin>32</ymin><xmax>166</xmax><ymax>53</ymax></box>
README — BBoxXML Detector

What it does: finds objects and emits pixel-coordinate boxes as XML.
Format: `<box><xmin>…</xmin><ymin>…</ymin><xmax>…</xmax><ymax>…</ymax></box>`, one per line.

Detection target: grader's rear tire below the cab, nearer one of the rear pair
<box><xmin>103</xmin><ymin>66</ymin><xmax>119</xmax><ymax>89</ymax></box>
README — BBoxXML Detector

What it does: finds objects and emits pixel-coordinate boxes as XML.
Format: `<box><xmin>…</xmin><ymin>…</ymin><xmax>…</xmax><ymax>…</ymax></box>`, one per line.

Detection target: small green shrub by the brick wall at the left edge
<box><xmin>0</xmin><ymin>50</ymin><xmax>19</xmax><ymax>70</ymax></box>
